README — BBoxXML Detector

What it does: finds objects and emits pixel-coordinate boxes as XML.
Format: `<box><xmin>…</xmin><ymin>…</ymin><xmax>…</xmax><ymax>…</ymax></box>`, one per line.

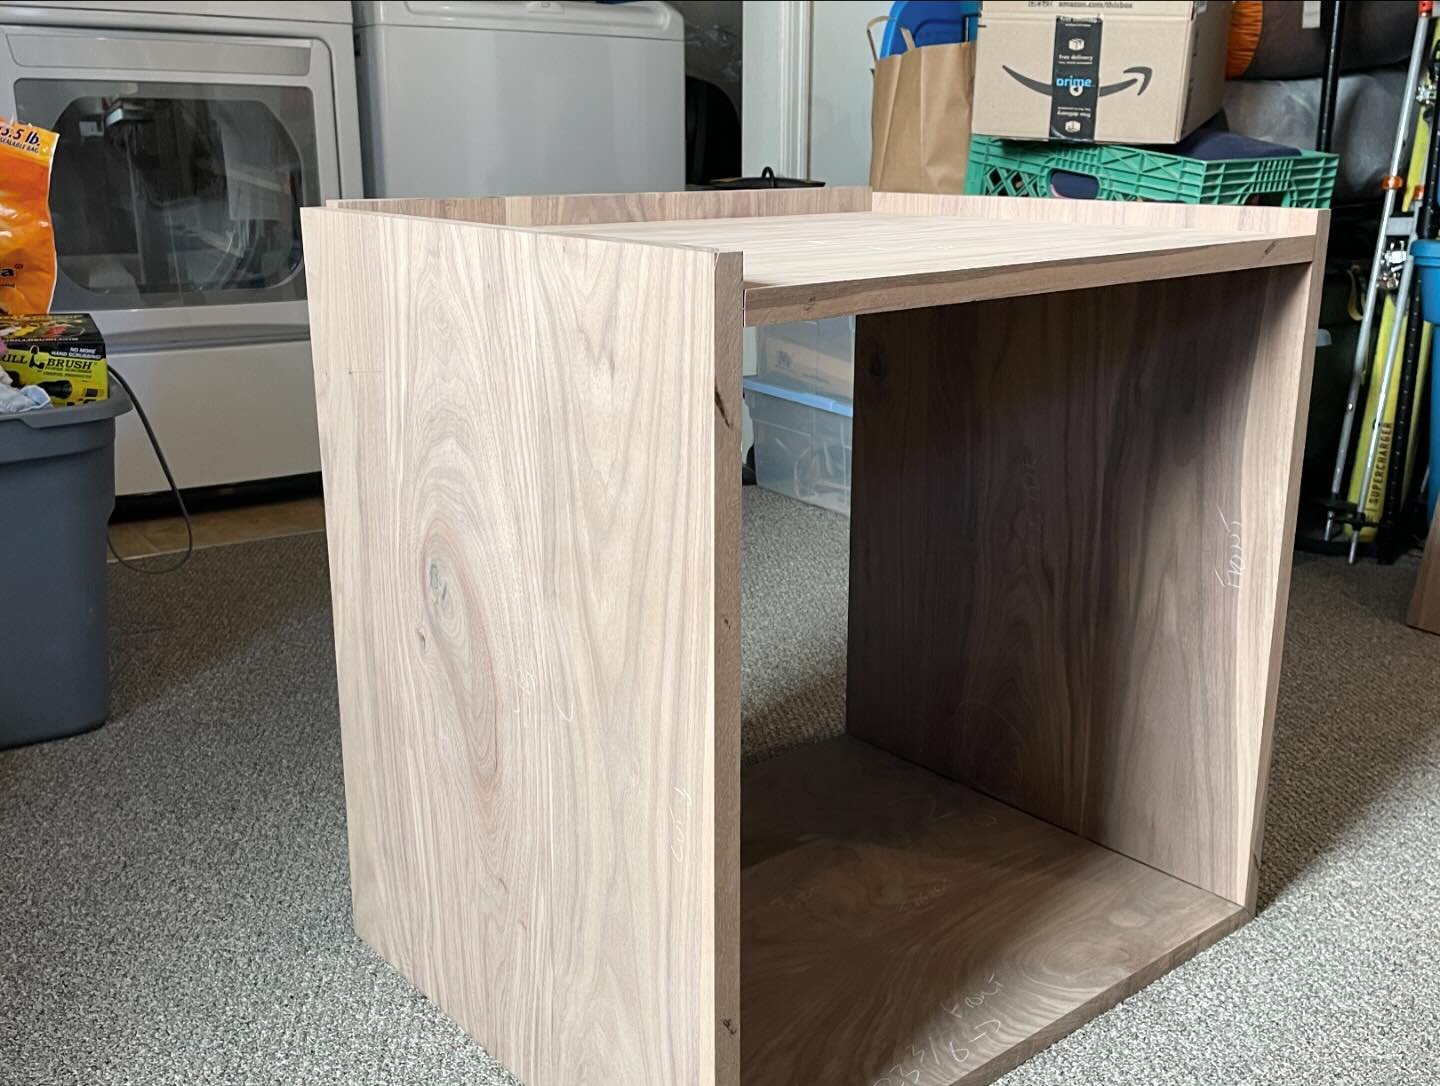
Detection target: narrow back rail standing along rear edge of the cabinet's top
<box><xmin>330</xmin><ymin>187</ymin><xmax>870</xmax><ymax>226</ymax></box>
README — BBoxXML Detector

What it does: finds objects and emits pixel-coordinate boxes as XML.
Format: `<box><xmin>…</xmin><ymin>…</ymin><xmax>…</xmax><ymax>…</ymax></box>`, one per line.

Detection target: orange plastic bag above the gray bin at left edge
<box><xmin>0</xmin><ymin>117</ymin><xmax>59</xmax><ymax>314</ymax></box>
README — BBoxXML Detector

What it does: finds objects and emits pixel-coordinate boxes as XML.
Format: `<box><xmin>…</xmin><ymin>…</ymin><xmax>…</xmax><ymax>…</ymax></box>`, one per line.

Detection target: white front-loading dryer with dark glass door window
<box><xmin>0</xmin><ymin>0</ymin><xmax>363</xmax><ymax>494</ymax></box>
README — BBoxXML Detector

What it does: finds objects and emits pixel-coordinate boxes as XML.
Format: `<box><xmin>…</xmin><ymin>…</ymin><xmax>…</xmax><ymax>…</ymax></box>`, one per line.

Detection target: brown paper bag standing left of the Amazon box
<box><xmin>865</xmin><ymin>16</ymin><xmax>975</xmax><ymax>193</ymax></box>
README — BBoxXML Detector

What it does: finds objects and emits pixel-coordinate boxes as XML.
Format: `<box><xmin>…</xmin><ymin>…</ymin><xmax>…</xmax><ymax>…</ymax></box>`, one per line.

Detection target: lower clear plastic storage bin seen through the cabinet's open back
<box><xmin>744</xmin><ymin>374</ymin><xmax>854</xmax><ymax>517</ymax></box>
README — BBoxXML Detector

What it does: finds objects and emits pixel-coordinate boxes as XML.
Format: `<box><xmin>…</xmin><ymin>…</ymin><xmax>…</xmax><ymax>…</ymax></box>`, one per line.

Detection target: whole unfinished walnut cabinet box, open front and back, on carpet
<box><xmin>305</xmin><ymin>189</ymin><xmax>1326</xmax><ymax>1086</ymax></box>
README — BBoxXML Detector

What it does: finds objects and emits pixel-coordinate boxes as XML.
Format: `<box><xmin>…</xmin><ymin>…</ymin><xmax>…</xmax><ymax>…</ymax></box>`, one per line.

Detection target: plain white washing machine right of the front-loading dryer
<box><xmin>356</xmin><ymin>0</ymin><xmax>685</xmax><ymax>196</ymax></box>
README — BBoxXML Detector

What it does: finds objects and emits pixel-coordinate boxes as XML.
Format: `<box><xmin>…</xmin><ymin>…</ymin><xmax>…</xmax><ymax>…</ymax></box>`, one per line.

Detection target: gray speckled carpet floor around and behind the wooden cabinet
<box><xmin>0</xmin><ymin>491</ymin><xmax>1440</xmax><ymax>1086</ymax></box>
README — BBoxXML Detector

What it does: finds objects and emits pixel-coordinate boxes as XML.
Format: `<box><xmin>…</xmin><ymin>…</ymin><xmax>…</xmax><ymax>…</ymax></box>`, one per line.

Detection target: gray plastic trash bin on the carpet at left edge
<box><xmin>0</xmin><ymin>387</ymin><xmax>131</xmax><ymax>749</ymax></box>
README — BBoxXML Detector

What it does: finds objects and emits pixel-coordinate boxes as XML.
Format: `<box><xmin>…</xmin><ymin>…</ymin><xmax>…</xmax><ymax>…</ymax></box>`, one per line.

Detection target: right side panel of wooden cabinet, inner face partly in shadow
<box><xmin>848</xmin><ymin>265</ymin><xmax>1319</xmax><ymax>905</ymax></box>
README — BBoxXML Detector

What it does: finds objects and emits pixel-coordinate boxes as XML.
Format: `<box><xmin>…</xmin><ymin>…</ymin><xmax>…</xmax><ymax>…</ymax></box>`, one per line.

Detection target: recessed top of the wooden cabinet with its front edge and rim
<box><xmin>331</xmin><ymin>187</ymin><xmax>1325</xmax><ymax>326</ymax></box>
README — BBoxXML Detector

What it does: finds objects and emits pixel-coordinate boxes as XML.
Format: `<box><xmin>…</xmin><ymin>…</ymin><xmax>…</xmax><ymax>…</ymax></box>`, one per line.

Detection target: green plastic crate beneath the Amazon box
<box><xmin>965</xmin><ymin>135</ymin><xmax>1339</xmax><ymax>207</ymax></box>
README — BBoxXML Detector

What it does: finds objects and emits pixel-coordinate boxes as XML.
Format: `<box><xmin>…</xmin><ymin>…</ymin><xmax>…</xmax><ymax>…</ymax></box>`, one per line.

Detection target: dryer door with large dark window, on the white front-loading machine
<box><xmin>0</xmin><ymin>26</ymin><xmax>340</xmax><ymax>353</ymax></box>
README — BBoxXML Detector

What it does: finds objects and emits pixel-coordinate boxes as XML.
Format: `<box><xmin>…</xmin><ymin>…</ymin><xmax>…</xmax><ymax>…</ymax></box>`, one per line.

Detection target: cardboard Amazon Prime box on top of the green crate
<box><xmin>971</xmin><ymin>0</ymin><xmax>1230</xmax><ymax>144</ymax></box>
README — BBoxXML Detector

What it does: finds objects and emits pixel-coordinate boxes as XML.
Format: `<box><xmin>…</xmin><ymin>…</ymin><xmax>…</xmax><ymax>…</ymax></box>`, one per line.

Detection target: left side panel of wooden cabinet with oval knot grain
<box><xmin>305</xmin><ymin>210</ymin><xmax>740</xmax><ymax>1086</ymax></box>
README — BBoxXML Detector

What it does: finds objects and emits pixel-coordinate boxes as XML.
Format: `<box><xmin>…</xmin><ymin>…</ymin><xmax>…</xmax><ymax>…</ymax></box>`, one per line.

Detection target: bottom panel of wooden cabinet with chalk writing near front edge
<box><xmin>743</xmin><ymin>739</ymin><xmax>1246</xmax><ymax>1086</ymax></box>
